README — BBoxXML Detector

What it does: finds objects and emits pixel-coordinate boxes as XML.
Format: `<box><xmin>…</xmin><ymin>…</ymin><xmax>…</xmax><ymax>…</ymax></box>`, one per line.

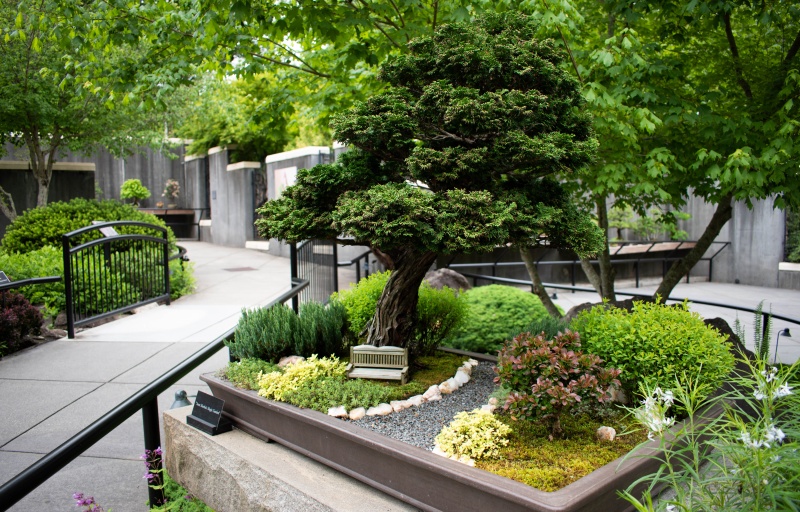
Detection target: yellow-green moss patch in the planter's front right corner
<box><xmin>475</xmin><ymin>414</ymin><xmax>647</xmax><ymax>492</ymax></box>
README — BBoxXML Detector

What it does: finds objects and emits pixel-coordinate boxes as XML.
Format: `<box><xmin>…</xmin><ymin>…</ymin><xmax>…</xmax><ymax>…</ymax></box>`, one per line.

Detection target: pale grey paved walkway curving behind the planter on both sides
<box><xmin>0</xmin><ymin>242</ymin><xmax>800</xmax><ymax>512</ymax></box>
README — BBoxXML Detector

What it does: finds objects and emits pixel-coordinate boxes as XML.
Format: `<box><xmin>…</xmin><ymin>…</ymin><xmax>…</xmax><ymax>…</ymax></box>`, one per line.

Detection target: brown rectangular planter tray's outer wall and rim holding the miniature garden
<box><xmin>201</xmin><ymin>374</ymin><xmax>659</xmax><ymax>512</ymax></box>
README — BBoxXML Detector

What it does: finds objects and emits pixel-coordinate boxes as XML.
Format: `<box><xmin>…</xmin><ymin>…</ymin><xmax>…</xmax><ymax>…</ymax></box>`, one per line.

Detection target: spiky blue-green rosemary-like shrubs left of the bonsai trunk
<box><xmin>226</xmin><ymin>300</ymin><xmax>345</xmax><ymax>362</ymax></box>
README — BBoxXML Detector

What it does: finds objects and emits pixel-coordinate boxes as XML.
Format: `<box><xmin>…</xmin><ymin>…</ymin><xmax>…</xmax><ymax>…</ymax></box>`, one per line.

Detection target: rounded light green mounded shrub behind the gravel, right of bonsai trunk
<box><xmin>447</xmin><ymin>284</ymin><xmax>549</xmax><ymax>354</ymax></box>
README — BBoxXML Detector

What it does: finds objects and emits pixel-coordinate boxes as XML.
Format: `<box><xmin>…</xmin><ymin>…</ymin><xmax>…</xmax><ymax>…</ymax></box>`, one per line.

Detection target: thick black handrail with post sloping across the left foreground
<box><xmin>0</xmin><ymin>279</ymin><xmax>309</xmax><ymax>510</ymax></box>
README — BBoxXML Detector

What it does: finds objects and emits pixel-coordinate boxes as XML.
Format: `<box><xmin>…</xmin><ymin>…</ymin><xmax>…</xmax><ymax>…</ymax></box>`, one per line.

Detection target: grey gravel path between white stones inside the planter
<box><xmin>352</xmin><ymin>362</ymin><xmax>496</xmax><ymax>450</ymax></box>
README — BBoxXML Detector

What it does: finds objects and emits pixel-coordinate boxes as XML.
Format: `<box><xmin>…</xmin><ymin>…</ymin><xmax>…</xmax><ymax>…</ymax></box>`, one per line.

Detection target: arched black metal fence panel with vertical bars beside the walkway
<box><xmin>61</xmin><ymin>221</ymin><xmax>169</xmax><ymax>338</ymax></box>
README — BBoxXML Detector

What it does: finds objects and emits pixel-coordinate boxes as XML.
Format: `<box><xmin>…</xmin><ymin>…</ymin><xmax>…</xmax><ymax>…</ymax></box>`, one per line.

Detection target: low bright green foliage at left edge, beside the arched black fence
<box><xmin>0</xmin><ymin>245</ymin><xmax>66</xmax><ymax>316</ymax></box>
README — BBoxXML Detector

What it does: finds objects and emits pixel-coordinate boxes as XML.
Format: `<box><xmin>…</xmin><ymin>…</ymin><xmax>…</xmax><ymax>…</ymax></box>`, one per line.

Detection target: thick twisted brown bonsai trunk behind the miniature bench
<box><xmin>367</xmin><ymin>250</ymin><xmax>436</xmax><ymax>347</ymax></box>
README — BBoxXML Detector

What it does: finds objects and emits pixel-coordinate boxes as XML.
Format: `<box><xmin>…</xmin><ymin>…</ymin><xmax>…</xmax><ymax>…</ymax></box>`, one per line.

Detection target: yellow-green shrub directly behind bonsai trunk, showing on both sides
<box><xmin>333</xmin><ymin>270</ymin><xmax>467</xmax><ymax>359</ymax></box>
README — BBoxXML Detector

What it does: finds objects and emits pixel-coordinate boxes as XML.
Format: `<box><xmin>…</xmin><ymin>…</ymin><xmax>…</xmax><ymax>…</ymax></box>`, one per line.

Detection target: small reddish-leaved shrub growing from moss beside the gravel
<box><xmin>495</xmin><ymin>331</ymin><xmax>620</xmax><ymax>437</ymax></box>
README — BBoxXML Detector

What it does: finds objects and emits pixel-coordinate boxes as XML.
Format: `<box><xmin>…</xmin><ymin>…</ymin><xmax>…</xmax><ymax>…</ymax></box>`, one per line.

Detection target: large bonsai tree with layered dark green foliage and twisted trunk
<box><xmin>256</xmin><ymin>13</ymin><xmax>602</xmax><ymax>347</ymax></box>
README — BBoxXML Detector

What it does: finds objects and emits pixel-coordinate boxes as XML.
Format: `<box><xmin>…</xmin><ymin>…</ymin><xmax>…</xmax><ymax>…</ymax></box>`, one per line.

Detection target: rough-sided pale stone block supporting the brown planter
<box><xmin>164</xmin><ymin>407</ymin><xmax>416</xmax><ymax>512</ymax></box>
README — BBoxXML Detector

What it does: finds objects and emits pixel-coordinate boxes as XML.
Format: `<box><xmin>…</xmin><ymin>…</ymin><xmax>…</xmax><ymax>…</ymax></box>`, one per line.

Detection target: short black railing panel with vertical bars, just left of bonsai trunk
<box><xmin>289</xmin><ymin>240</ymin><xmax>339</xmax><ymax>309</ymax></box>
